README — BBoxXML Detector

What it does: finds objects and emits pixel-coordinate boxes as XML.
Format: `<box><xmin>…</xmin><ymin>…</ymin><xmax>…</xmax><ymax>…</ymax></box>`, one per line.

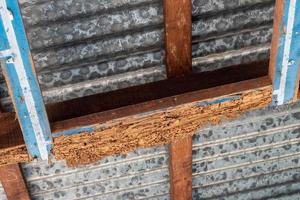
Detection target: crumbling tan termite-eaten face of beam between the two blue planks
<box><xmin>53</xmin><ymin>86</ymin><xmax>272</xmax><ymax>166</ymax></box>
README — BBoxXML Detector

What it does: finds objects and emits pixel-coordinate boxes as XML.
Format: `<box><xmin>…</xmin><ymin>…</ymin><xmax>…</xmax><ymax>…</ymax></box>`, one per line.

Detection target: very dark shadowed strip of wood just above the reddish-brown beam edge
<box><xmin>47</xmin><ymin>61</ymin><xmax>269</xmax><ymax>122</ymax></box>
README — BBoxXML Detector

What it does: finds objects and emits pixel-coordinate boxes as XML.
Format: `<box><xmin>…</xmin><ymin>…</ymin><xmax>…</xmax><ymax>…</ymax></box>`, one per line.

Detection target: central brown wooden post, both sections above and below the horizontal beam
<box><xmin>164</xmin><ymin>0</ymin><xmax>192</xmax><ymax>200</ymax></box>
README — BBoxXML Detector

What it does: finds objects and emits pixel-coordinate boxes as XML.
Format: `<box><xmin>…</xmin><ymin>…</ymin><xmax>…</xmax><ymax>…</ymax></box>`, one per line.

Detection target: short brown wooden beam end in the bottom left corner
<box><xmin>0</xmin><ymin>164</ymin><xmax>30</xmax><ymax>200</ymax></box>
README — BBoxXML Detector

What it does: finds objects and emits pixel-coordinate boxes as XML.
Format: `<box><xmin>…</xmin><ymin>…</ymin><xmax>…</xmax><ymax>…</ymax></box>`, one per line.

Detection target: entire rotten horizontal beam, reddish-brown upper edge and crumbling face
<box><xmin>0</xmin><ymin>77</ymin><xmax>272</xmax><ymax>165</ymax></box>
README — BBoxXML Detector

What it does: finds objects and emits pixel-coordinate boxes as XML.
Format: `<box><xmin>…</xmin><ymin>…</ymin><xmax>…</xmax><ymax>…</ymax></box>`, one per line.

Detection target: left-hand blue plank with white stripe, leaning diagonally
<box><xmin>0</xmin><ymin>0</ymin><xmax>52</xmax><ymax>160</ymax></box>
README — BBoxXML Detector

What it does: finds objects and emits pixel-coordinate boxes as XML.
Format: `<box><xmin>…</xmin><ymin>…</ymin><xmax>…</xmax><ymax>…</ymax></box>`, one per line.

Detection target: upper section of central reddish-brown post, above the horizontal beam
<box><xmin>164</xmin><ymin>0</ymin><xmax>192</xmax><ymax>78</ymax></box>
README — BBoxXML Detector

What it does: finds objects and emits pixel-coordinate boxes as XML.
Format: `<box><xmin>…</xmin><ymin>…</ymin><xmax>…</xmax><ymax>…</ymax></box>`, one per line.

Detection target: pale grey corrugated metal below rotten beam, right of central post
<box><xmin>193</xmin><ymin>102</ymin><xmax>300</xmax><ymax>200</ymax></box>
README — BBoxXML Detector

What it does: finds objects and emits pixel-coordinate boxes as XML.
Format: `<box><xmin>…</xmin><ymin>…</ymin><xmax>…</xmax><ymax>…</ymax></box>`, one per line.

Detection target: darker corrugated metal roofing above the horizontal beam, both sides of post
<box><xmin>0</xmin><ymin>0</ymin><xmax>274</xmax><ymax>110</ymax></box>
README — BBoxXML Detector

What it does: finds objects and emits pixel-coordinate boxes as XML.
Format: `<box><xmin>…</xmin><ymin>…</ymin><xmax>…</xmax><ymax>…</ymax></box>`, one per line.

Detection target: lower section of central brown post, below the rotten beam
<box><xmin>169</xmin><ymin>136</ymin><xmax>192</xmax><ymax>200</ymax></box>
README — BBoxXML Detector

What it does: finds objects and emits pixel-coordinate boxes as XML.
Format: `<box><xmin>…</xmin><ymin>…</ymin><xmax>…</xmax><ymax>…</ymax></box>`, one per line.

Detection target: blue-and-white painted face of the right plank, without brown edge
<box><xmin>273</xmin><ymin>0</ymin><xmax>300</xmax><ymax>105</ymax></box>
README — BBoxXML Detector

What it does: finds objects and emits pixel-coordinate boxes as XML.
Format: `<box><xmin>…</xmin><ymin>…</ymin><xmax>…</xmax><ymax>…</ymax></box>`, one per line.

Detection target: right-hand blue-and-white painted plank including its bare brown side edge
<box><xmin>269</xmin><ymin>0</ymin><xmax>300</xmax><ymax>105</ymax></box>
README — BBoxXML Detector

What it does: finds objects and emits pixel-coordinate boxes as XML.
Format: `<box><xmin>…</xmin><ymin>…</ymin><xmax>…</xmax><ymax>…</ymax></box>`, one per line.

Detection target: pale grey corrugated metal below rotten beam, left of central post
<box><xmin>22</xmin><ymin>147</ymin><xmax>169</xmax><ymax>200</ymax></box>
